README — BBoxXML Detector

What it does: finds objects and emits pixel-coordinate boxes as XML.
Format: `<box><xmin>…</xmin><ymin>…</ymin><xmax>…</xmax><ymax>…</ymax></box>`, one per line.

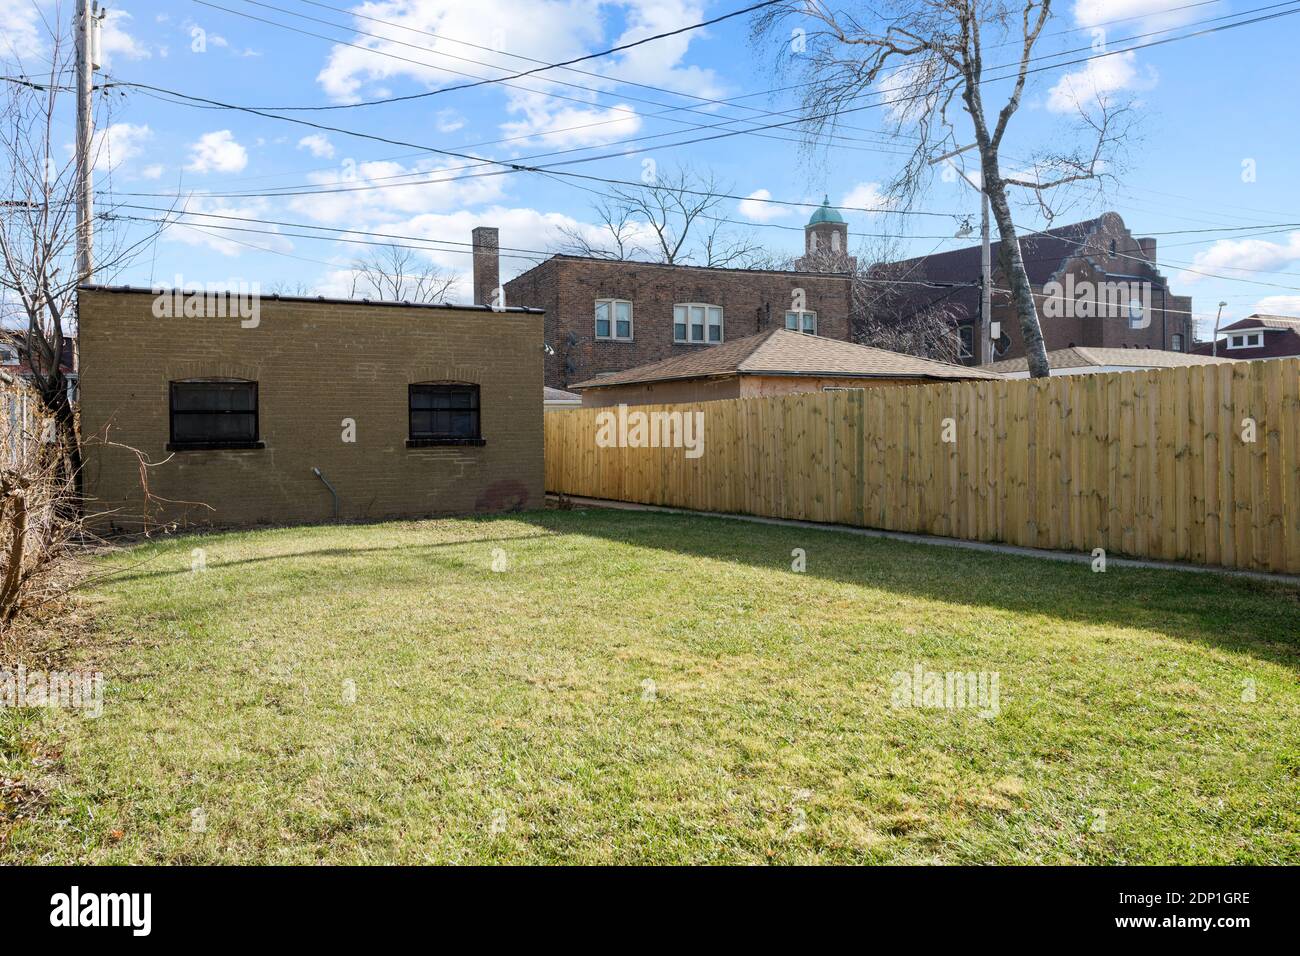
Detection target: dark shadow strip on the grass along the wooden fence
<box><xmin>521</xmin><ymin>509</ymin><xmax>1300</xmax><ymax>669</ymax></box>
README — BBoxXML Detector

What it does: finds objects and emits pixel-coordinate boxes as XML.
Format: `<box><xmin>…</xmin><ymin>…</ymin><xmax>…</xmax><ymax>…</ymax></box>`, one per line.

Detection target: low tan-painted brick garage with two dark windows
<box><xmin>78</xmin><ymin>286</ymin><xmax>543</xmax><ymax>528</ymax></box>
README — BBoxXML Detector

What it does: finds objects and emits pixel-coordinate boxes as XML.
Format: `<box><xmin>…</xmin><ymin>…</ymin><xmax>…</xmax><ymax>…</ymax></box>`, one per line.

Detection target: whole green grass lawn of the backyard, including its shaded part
<box><xmin>0</xmin><ymin>511</ymin><xmax>1300</xmax><ymax>864</ymax></box>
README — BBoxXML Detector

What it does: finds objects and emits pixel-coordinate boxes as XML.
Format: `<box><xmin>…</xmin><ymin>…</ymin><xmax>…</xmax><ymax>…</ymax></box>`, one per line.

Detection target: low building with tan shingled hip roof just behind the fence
<box><xmin>573</xmin><ymin>329</ymin><xmax>1001</xmax><ymax>407</ymax></box>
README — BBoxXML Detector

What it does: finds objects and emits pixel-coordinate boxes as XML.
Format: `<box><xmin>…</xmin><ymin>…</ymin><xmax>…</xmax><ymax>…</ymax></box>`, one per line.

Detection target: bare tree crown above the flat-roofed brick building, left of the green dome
<box><xmin>560</xmin><ymin>166</ymin><xmax>763</xmax><ymax>268</ymax></box>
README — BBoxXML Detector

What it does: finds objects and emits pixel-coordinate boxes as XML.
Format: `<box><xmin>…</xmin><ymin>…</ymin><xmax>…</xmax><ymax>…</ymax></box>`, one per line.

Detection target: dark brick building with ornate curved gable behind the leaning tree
<box><xmin>879</xmin><ymin>212</ymin><xmax>1192</xmax><ymax>364</ymax></box>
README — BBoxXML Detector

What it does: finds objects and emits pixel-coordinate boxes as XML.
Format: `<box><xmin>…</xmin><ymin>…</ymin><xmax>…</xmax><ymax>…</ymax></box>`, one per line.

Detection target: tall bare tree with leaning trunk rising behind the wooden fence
<box><xmin>753</xmin><ymin>0</ymin><xmax>1126</xmax><ymax>376</ymax></box>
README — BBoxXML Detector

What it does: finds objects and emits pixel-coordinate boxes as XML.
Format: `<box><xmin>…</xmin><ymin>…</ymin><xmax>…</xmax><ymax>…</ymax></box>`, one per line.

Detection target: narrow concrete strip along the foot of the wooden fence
<box><xmin>546</xmin><ymin>493</ymin><xmax>1300</xmax><ymax>587</ymax></box>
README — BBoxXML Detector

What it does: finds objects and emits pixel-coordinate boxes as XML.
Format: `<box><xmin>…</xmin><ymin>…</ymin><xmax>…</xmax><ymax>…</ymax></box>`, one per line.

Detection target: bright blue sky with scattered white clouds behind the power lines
<box><xmin>10</xmin><ymin>0</ymin><xmax>1300</xmax><ymax>338</ymax></box>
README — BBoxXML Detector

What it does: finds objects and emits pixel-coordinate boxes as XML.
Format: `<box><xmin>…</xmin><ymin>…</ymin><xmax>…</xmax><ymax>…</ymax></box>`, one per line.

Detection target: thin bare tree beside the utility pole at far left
<box><xmin>0</xmin><ymin>14</ymin><xmax>157</xmax><ymax>494</ymax></box>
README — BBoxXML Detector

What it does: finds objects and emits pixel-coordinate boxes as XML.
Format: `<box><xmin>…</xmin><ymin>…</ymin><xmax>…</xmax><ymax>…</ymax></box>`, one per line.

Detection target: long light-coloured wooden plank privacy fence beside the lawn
<box><xmin>545</xmin><ymin>359</ymin><xmax>1300</xmax><ymax>572</ymax></box>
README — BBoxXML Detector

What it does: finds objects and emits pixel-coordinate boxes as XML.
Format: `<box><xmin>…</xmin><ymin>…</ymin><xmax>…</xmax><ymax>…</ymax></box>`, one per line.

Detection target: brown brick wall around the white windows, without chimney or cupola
<box><xmin>506</xmin><ymin>256</ymin><xmax>850</xmax><ymax>389</ymax></box>
